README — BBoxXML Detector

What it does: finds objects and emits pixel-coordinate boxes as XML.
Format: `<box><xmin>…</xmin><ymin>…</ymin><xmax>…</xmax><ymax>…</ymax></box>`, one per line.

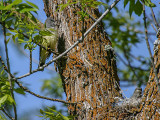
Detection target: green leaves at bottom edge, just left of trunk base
<box><xmin>39</xmin><ymin>107</ymin><xmax>73</xmax><ymax>120</ymax></box>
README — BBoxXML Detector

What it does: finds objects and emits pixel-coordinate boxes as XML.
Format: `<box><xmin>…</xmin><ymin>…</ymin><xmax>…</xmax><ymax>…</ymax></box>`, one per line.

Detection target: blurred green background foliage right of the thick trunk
<box><xmin>103</xmin><ymin>0</ymin><xmax>154</xmax><ymax>86</ymax></box>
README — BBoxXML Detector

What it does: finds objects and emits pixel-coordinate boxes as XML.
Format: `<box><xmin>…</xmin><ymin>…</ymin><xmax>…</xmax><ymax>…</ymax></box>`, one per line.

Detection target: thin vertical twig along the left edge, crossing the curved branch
<box><xmin>3</xmin><ymin>22</ymin><xmax>17</xmax><ymax>120</ymax></box>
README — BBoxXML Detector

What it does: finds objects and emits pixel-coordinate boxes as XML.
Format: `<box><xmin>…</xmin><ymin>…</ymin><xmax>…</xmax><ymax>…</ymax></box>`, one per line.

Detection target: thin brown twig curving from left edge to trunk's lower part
<box><xmin>0</xmin><ymin>56</ymin><xmax>76</xmax><ymax>104</ymax></box>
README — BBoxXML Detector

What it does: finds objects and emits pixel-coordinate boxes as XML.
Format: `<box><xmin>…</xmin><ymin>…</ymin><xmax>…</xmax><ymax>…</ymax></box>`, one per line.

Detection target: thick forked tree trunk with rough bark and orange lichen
<box><xmin>43</xmin><ymin>0</ymin><xmax>160</xmax><ymax>120</ymax></box>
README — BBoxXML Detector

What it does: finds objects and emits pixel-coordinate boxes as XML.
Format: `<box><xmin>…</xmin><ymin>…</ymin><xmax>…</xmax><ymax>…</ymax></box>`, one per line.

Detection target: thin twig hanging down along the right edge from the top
<box><xmin>143</xmin><ymin>0</ymin><xmax>160</xmax><ymax>91</ymax></box>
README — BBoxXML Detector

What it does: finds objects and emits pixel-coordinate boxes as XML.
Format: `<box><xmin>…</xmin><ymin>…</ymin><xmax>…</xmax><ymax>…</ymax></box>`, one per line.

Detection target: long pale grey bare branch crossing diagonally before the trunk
<box><xmin>13</xmin><ymin>0</ymin><xmax>120</xmax><ymax>79</ymax></box>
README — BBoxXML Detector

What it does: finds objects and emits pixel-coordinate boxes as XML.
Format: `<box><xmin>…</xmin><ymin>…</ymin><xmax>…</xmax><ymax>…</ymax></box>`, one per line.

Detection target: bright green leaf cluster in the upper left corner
<box><xmin>0</xmin><ymin>0</ymin><xmax>40</xmax><ymax>50</ymax></box>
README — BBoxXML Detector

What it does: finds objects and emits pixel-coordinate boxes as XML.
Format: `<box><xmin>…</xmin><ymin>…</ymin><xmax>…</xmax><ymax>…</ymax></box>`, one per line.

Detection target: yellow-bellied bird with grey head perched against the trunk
<box><xmin>38</xmin><ymin>17</ymin><xmax>58</xmax><ymax>67</ymax></box>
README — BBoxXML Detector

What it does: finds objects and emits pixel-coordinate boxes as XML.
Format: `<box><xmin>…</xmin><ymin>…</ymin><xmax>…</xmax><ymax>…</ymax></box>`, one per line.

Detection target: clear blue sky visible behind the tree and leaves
<box><xmin>0</xmin><ymin>0</ymin><xmax>159</xmax><ymax>120</ymax></box>
